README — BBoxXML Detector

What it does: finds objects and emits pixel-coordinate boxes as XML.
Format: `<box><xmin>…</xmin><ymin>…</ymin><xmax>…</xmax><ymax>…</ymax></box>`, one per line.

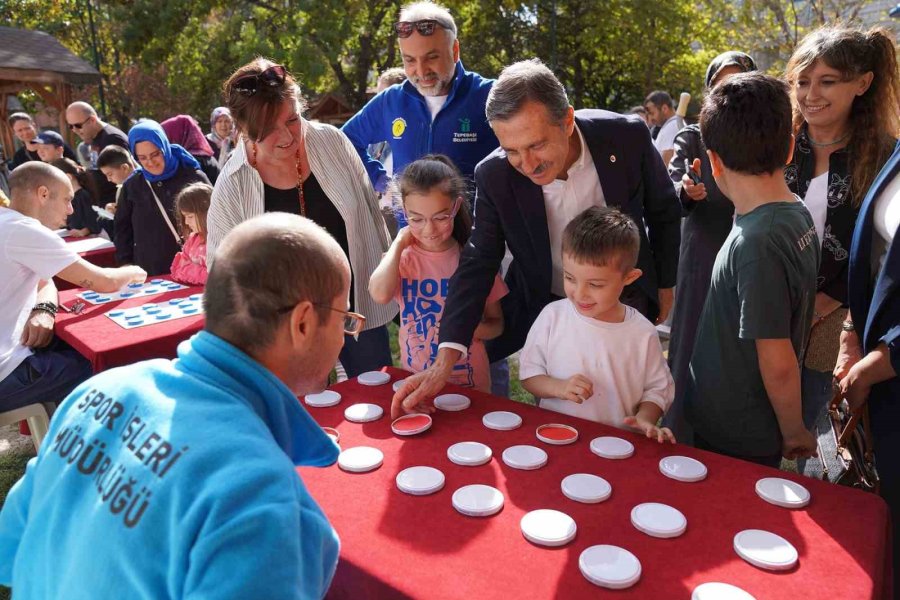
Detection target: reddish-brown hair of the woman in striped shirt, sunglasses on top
<box><xmin>222</xmin><ymin>57</ymin><xmax>306</xmax><ymax>142</ymax></box>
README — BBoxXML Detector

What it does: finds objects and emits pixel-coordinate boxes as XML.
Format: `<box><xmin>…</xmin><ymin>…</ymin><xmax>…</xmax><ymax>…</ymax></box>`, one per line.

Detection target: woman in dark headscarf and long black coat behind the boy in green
<box><xmin>663</xmin><ymin>52</ymin><xmax>756</xmax><ymax>444</ymax></box>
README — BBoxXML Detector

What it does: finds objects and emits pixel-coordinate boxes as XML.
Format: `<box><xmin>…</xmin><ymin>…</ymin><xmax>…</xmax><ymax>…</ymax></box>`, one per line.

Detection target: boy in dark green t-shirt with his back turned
<box><xmin>685</xmin><ymin>73</ymin><xmax>820</xmax><ymax>467</ymax></box>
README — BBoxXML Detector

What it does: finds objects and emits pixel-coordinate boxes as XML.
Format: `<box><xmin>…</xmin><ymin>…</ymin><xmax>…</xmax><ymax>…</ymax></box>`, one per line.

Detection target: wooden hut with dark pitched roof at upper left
<box><xmin>0</xmin><ymin>27</ymin><xmax>100</xmax><ymax>158</ymax></box>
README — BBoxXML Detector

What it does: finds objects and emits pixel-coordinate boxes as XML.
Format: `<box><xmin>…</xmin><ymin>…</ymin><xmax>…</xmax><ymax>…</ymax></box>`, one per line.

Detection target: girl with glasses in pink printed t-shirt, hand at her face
<box><xmin>369</xmin><ymin>154</ymin><xmax>508</xmax><ymax>393</ymax></box>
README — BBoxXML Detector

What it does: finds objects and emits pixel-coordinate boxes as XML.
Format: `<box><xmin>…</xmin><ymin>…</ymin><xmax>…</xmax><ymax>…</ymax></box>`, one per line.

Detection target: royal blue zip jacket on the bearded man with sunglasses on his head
<box><xmin>341</xmin><ymin>61</ymin><xmax>499</xmax><ymax>192</ymax></box>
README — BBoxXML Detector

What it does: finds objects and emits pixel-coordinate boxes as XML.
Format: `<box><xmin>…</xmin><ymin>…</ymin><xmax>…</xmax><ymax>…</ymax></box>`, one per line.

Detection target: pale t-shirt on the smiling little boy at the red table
<box><xmin>519</xmin><ymin>298</ymin><xmax>675</xmax><ymax>429</ymax></box>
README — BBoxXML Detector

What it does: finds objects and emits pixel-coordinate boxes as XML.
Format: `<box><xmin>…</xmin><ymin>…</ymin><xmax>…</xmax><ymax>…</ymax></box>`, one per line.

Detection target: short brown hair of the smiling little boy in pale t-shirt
<box><xmin>562</xmin><ymin>206</ymin><xmax>641</xmax><ymax>273</ymax></box>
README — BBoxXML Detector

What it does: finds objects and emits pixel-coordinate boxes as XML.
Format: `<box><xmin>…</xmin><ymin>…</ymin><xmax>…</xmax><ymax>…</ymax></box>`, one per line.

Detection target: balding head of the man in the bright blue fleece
<box><xmin>203</xmin><ymin>213</ymin><xmax>350</xmax><ymax>354</ymax></box>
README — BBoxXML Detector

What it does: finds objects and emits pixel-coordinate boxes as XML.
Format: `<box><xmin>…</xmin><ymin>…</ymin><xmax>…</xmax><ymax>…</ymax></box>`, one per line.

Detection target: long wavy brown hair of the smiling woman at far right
<box><xmin>785</xmin><ymin>25</ymin><xmax>900</xmax><ymax>207</ymax></box>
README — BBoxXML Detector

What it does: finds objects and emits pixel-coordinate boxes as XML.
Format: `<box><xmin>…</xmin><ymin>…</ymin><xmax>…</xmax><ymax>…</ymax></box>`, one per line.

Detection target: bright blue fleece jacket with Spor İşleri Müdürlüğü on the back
<box><xmin>0</xmin><ymin>332</ymin><xmax>338</xmax><ymax>600</ymax></box>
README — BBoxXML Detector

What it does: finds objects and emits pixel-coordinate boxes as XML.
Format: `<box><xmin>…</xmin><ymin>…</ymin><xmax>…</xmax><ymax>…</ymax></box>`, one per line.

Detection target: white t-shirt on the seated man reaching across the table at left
<box><xmin>0</xmin><ymin>208</ymin><xmax>78</xmax><ymax>381</ymax></box>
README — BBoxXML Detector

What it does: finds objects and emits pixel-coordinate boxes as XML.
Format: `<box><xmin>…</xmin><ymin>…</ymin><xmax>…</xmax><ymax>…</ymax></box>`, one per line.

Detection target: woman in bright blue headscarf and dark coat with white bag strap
<box><xmin>115</xmin><ymin>119</ymin><xmax>209</xmax><ymax>275</ymax></box>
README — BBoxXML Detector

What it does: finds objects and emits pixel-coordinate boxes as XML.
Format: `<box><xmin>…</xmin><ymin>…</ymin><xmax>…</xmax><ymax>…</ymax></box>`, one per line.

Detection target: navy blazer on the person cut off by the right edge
<box><xmin>848</xmin><ymin>144</ymin><xmax>900</xmax><ymax>384</ymax></box>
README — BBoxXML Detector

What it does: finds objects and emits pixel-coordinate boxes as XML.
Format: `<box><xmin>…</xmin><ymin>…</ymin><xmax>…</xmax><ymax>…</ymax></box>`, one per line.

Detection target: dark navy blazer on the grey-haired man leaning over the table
<box><xmin>440</xmin><ymin>110</ymin><xmax>681</xmax><ymax>361</ymax></box>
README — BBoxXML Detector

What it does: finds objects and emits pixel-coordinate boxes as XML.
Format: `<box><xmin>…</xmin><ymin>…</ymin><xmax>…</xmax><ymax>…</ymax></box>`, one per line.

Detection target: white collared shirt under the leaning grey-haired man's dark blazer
<box><xmin>541</xmin><ymin>125</ymin><xmax>606</xmax><ymax>296</ymax></box>
